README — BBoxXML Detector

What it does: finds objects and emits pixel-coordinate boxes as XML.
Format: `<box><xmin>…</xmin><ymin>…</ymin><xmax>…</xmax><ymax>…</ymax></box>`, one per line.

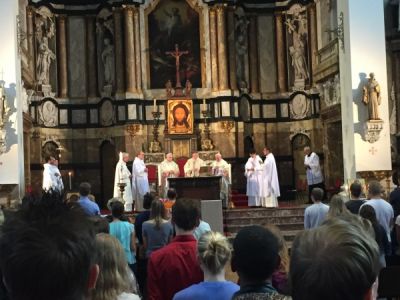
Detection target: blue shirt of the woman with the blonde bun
<box><xmin>173</xmin><ymin>281</ymin><xmax>239</xmax><ymax>300</ymax></box>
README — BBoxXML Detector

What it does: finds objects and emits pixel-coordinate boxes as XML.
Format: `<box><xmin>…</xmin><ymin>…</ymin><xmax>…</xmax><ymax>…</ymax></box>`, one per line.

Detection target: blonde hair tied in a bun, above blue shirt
<box><xmin>197</xmin><ymin>231</ymin><xmax>232</xmax><ymax>275</ymax></box>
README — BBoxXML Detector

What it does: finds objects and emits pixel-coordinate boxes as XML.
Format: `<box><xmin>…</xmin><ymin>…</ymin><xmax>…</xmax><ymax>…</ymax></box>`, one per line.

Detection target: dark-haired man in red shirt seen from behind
<box><xmin>147</xmin><ymin>198</ymin><xmax>203</xmax><ymax>300</ymax></box>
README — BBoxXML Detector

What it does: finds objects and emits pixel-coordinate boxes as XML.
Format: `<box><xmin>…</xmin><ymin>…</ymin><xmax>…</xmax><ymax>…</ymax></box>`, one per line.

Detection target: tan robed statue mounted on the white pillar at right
<box><xmin>363</xmin><ymin>73</ymin><xmax>381</xmax><ymax>120</ymax></box>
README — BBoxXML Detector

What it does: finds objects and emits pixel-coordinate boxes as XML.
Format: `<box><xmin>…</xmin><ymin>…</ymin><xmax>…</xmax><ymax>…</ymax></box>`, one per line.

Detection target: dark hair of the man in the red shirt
<box><xmin>172</xmin><ymin>198</ymin><xmax>200</xmax><ymax>231</ymax></box>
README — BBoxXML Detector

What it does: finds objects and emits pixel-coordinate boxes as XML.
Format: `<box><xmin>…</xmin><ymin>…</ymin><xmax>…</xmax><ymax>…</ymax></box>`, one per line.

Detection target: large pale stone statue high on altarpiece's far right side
<box><xmin>285</xmin><ymin>5</ymin><xmax>310</xmax><ymax>87</ymax></box>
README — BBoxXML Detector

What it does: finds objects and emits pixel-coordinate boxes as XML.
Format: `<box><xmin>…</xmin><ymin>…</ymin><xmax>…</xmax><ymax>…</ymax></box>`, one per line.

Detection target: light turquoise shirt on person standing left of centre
<box><xmin>110</xmin><ymin>221</ymin><xmax>136</xmax><ymax>265</ymax></box>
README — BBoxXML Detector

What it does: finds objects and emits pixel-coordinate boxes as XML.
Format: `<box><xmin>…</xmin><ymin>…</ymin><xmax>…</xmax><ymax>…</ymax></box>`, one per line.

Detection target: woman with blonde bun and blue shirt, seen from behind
<box><xmin>173</xmin><ymin>231</ymin><xmax>239</xmax><ymax>300</ymax></box>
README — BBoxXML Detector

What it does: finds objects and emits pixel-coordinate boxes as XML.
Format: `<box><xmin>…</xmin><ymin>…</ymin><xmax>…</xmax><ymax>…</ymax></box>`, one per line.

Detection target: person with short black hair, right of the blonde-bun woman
<box><xmin>231</xmin><ymin>225</ymin><xmax>290</xmax><ymax>300</ymax></box>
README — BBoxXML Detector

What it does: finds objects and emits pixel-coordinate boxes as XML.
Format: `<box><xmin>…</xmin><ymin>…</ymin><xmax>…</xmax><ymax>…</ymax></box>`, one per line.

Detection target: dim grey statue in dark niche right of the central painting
<box><xmin>235</xmin><ymin>9</ymin><xmax>249</xmax><ymax>89</ymax></box>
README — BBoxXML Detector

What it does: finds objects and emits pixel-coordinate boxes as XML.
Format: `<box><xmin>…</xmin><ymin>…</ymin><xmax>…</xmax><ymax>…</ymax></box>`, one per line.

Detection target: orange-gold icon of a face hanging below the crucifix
<box><xmin>167</xmin><ymin>99</ymin><xmax>193</xmax><ymax>134</ymax></box>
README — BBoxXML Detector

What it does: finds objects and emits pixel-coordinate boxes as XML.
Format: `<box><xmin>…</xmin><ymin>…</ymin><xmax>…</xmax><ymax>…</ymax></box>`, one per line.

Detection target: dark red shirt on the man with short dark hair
<box><xmin>147</xmin><ymin>235</ymin><xmax>203</xmax><ymax>300</ymax></box>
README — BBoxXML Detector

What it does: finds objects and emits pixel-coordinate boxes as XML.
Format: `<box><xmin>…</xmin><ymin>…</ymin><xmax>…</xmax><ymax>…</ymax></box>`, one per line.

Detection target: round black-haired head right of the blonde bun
<box><xmin>232</xmin><ymin>225</ymin><xmax>280</xmax><ymax>284</ymax></box>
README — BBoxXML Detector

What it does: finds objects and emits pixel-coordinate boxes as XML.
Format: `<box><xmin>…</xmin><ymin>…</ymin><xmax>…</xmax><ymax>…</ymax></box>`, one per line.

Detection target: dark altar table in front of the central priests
<box><xmin>168</xmin><ymin>176</ymin><xmax>221</xmax><ymax>200</ymax></box>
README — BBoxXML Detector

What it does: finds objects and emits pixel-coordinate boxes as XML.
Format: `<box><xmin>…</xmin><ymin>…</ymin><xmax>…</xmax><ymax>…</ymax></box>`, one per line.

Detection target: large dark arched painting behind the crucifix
<box><xmin>148</xmin><ymin>0</ymin><xmax>202</xmax><ymax>89</ymax></box>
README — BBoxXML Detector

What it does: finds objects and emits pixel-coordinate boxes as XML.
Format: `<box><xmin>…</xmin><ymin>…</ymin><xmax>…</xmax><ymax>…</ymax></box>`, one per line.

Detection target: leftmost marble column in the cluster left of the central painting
<box><xmin>113</xmin><ymin>8</ymin><xmax>125</xmax><ymax>94</ymax></box>
